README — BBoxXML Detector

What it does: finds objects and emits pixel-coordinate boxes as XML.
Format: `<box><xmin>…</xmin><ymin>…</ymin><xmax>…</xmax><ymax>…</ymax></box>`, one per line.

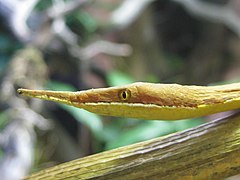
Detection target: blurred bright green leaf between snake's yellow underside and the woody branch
<box><xmin>104</xmin><ymin>119</ymin><xmax>202</xmax><ymax>149</ymax></box>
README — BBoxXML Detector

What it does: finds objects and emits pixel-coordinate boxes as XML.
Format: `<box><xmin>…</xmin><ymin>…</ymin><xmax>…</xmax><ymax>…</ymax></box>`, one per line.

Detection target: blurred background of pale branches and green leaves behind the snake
<box><xmin>0</xmin><ymin>0</ymin><xmax>240</xmax><ymax>179</ymax></box>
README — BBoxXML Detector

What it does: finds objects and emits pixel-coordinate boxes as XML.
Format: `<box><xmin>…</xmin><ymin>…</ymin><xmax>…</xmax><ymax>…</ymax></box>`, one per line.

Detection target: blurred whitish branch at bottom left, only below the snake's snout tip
<box><xmin>0</xmin><ymin>106</ymin><xmax>50</xmax><ymax>180</ymax></box>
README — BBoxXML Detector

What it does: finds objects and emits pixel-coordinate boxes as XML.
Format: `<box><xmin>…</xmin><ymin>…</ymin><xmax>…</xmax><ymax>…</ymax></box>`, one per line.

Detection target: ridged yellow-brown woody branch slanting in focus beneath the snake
<box><xmin>26</xmin><ymin>114</ymin><xmax>240</xmax><ymax>179</ymax></box>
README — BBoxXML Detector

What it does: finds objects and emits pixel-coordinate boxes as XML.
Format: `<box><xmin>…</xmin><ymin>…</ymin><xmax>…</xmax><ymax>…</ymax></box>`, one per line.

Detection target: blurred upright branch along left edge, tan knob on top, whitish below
<box><xmin>0</xmin><ymin>47</ymin><xmax>51</xmax><ymax>179</ymax></box>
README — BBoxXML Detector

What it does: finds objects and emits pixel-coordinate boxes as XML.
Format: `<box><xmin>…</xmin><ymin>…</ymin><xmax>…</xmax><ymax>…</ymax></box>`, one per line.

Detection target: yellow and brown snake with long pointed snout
<box><xmin>17</xmin><ymin>82</ymin><xmax>240</xmax><ymax>120</ymax></box>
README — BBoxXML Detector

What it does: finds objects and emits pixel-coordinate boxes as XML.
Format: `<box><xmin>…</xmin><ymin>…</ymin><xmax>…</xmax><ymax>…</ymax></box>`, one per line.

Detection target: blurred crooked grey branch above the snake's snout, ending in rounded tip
<box><xmin>49</xmin><ymin>0</ymin><xmax>132</xmax><ymax>60</ymax></box>
